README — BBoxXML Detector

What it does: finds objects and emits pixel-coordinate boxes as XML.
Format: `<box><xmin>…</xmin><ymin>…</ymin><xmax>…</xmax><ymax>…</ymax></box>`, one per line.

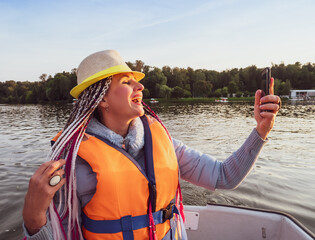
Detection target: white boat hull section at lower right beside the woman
<box><xmin>184</xmin><ymin>205</ymin><xmax>315</xmax><ymax>240</ymax></box>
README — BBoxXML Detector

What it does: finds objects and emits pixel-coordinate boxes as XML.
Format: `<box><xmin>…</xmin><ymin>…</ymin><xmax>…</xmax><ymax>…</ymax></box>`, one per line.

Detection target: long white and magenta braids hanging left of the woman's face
<box><xmin>48</xmin><ymin>76</ymin><xmax>112</xmax><ymax>240</ymax></box>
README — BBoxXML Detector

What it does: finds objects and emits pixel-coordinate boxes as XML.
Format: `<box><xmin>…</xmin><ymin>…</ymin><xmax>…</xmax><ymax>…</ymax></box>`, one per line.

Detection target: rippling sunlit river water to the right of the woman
<box><xmin>149</xmin><ymin>103</ymin><xmax>315</xmax><ymax>231</ymax></box>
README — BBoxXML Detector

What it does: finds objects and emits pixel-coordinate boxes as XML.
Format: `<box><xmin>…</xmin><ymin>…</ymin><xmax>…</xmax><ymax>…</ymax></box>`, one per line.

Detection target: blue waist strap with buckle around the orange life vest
<box><xmin>81</xmin><ymin>204</ymin><xmax>179</xmax><ymax>235</ymax></box>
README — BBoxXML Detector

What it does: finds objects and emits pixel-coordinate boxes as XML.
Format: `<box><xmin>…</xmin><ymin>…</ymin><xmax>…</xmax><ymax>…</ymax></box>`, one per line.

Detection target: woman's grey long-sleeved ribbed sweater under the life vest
<box><xmin>23</xmin><ymin>117</ymin><xmax>266</xmax><ymax>240</ymax></box>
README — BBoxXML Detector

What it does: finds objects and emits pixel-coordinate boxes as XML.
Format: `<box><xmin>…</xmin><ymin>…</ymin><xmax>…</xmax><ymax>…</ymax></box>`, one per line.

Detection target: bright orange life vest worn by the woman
<box><xmin>78</xmin><ymin>117</ymin><xmax>178</xmax><ymax>240</ymax></box>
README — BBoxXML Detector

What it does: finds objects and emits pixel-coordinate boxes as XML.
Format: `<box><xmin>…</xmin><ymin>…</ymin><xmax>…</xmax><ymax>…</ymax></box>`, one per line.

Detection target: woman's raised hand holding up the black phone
<box><xmin>254</xmin><ymin>78</ymin><xmax>281</xmax><ymax>139</ymax></box>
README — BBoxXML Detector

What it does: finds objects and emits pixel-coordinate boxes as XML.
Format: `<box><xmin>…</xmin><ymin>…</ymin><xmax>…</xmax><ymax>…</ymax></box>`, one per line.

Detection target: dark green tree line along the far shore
<box><xmin>0</xmin><ymin>60</ymin><xmax>315</xmax><ymax>103</ymax></box>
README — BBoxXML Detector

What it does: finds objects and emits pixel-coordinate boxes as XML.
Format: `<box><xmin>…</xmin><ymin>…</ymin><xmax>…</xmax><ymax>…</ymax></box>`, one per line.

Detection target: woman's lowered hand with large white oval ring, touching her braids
<box><xmin>23</xmin><ymin>159</ymin><xmax>66</xmax><ymax>235</ymax></box>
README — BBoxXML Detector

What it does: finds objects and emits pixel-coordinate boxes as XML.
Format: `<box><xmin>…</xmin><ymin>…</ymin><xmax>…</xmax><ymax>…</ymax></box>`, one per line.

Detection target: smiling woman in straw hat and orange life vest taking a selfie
<box><xmin>23</xmin><ymin>50</ymin><xmax>280</xmax><ymax>239</ymax></box>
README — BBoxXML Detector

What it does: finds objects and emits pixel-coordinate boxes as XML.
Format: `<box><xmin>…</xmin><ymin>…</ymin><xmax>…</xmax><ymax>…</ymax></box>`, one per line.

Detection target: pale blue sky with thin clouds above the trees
<box><xmin>0</xmin><ymin>0</ymin><xmax>315</xmax><ymax>82</ymax></box>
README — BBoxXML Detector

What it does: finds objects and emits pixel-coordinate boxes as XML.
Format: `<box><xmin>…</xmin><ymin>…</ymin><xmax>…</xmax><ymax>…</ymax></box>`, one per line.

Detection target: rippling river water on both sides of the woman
<box><xmin>0</xmin><ymin>103</ymin><xmax>315</xmax><ymax>239</ymax></box>
